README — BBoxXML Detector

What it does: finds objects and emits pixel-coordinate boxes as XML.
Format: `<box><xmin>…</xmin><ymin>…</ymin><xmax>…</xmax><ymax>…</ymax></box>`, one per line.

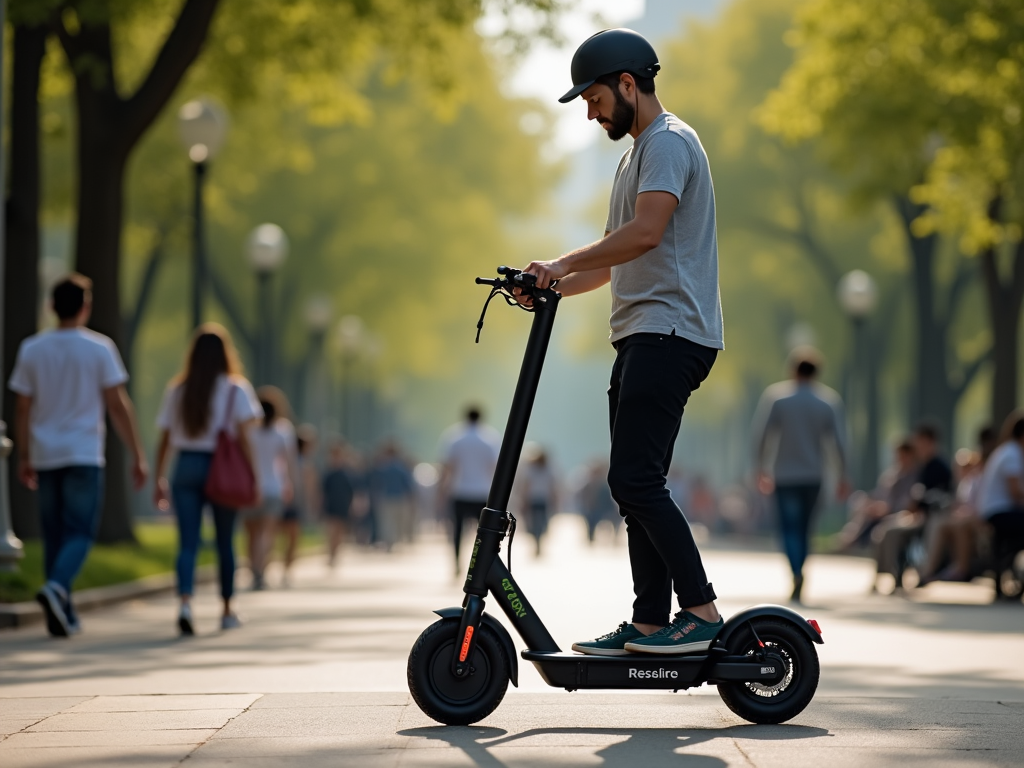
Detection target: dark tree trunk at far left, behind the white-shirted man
<box><xmin>3</xmin><ymin>25</ymin><xmax>48</xmax><ymax>539</ymax></box>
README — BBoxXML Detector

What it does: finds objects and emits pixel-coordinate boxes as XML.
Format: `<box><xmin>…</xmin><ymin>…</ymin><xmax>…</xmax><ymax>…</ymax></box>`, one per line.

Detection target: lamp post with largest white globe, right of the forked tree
<box><xmin>178</xmin><ymin>98</ymin><xmax>227</xmax><ymax>328</ymax></box>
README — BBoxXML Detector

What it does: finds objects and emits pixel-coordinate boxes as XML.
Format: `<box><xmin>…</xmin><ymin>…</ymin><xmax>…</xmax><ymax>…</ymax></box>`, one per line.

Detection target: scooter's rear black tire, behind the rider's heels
<box><xmin>718</xmin><ymin>618</ymin><xmax>820</xmax><ymax>724</ymax></box>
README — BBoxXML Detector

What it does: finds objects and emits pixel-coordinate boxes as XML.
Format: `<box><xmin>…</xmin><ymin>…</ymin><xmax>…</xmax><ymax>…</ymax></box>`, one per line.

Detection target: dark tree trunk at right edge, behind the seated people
<box><xmin>981</xmin><ymin>243</ymin><xmax>1024</xmax><ymax>429</ymax></box>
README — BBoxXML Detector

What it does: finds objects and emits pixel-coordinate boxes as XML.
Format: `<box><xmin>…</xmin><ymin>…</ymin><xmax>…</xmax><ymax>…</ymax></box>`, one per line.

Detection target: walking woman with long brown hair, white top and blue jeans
<box><xmin>154</xmin><ymin>323</ymin><xmax>263</xmax><ymax>635</ymax></box>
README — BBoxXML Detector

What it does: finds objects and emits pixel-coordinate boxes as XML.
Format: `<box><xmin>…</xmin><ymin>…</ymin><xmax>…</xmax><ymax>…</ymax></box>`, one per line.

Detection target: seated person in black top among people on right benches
<box><xmin>872</xmin><ymin>422</ymin><xmax>953</xmax><ymax>590</ymax></box>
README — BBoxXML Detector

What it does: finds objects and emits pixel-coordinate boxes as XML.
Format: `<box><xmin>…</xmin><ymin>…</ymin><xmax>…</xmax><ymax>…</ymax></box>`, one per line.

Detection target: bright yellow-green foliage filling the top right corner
<box><xmin>761</xmin><ymin>0</ymin><xmax>1024</xmax><ymax>253</ymax></box>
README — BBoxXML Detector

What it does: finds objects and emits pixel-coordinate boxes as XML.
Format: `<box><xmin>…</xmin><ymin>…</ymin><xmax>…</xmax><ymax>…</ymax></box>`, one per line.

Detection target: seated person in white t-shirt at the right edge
<box><xmin>978</xmin><ymin>411</ymin><xmax>1024</xmax><ymax>552</ymax></box>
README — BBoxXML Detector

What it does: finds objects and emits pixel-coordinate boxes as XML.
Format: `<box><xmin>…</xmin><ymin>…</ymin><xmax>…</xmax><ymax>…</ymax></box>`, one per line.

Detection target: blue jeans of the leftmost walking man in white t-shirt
<box><xmin>38</xmin><ymin>466</ymin><xmax>103</xmax><ymax>595</ymax></box>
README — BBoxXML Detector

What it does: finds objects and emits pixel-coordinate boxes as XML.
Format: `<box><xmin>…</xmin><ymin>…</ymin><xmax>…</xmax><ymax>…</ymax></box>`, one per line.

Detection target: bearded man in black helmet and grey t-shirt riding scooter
<box><xmin>522</xmin><ymin>30</ymin><xmax>723</xmax><ymax>655</ymax></box>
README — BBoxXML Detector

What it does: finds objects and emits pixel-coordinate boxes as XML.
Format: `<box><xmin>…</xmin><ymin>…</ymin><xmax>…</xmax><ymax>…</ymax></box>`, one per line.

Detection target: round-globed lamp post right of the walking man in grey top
<box><xmin>837</xmin><ymin>269</ymin><xmax>879</xmax><ymax>488</ymax></box>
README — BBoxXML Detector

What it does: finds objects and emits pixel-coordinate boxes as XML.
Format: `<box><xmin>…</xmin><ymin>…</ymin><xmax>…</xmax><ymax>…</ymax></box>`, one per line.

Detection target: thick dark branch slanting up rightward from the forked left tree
<box><xmin>123</xmin><ymin>0</ymin><xmax>220</xmax><ymax>145</ymax></box>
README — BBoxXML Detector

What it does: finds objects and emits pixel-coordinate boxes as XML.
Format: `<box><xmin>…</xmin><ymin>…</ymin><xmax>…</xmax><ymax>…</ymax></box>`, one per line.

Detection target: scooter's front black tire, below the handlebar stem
<box><xmin>408</xmin><ymin>617</ymin><xmax>510</xmax><ymax>725</ymax></box>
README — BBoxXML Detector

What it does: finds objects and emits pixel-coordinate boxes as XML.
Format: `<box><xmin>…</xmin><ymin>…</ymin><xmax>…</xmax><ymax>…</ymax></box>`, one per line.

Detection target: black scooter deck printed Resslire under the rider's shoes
<box><xmin>522</xmin><ymin>649</ymin><xmax>785</xmax><ymax>690</ymax></box>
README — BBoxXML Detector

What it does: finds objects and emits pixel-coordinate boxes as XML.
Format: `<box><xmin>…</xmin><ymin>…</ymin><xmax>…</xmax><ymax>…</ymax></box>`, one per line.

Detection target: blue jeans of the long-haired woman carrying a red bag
<box><xmin>171</xmin><ymin>451</ymin><xmax>238</xmax><ymax>600</ymax></box>
